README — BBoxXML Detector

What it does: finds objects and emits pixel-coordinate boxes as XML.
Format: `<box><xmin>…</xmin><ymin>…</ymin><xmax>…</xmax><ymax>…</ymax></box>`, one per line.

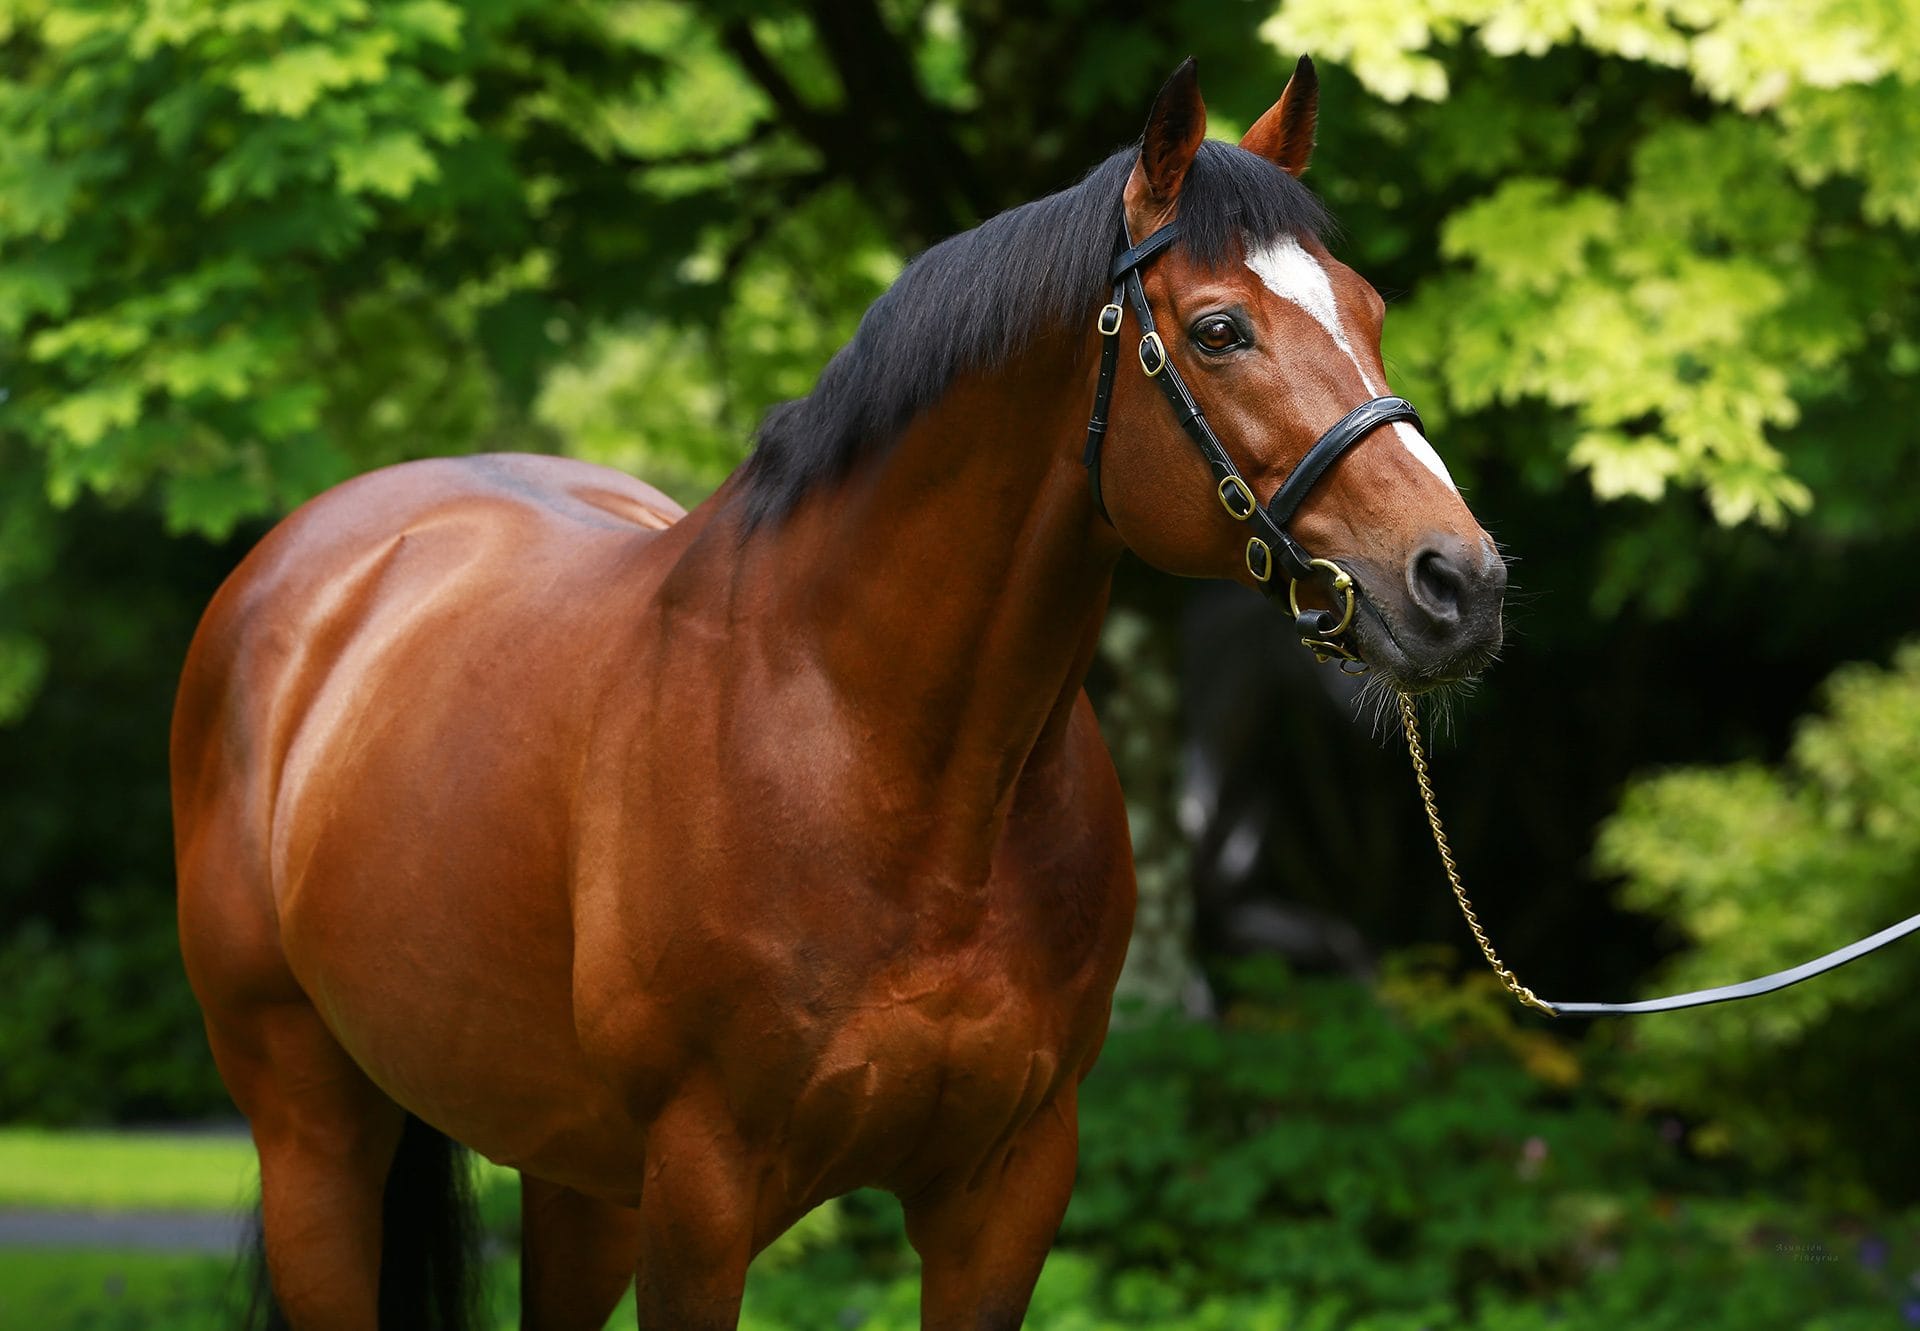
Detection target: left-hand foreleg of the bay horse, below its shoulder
<box><xmin>636</xmin><ymin>1087</ymin><xmax>758</xmax><ymax>1331</ymax></box>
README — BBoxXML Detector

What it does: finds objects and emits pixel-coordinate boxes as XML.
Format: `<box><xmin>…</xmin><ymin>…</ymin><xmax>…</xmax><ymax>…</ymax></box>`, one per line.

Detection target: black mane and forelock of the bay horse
<box><xmin>741</xmin><ymin>140</ymin><xmax>1332</xmax><ymax>526</ymax></box>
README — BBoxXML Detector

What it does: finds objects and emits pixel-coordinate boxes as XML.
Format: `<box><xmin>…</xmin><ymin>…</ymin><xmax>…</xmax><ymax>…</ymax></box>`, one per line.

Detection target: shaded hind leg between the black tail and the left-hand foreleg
<box><xmin>520</xmin><ymin>1174</ymin><xmax>639</xmax><ymax>1331</ymax></box>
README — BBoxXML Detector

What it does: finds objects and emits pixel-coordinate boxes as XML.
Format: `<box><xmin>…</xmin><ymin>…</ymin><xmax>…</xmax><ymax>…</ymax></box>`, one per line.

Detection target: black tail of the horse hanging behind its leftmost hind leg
<box><xmin>242</xmin><ymin>1114</ymin><xmax>480</xmax><ymax>1331</ymax></box>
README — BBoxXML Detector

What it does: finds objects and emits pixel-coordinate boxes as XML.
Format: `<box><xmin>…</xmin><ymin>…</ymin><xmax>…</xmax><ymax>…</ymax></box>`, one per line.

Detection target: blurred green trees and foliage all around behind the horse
<box><xmin>0</xmin><ymin>0</ymin><xmax>1920</xmax><ymax>1327</ymax></box>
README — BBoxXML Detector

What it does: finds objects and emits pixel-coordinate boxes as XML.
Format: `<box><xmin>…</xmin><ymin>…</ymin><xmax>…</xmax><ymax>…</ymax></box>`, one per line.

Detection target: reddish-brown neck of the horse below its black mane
<box><xmin>753</xmin><ymin>346</ymin><xmax>1121</xmax><ymax>870</ymax></box>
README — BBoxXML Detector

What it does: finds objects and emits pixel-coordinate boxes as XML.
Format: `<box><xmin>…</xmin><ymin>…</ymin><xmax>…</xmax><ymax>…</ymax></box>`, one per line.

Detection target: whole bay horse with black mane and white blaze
<box><xmin>171</xmin><ymin>61</ymin><xmax>1505</xmax><ymax>1331</ymax></box>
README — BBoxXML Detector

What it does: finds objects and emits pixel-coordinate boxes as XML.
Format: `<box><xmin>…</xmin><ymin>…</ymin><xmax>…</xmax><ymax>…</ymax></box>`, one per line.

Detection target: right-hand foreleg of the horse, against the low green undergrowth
<box><xmin>904</xmin><ymin>1091</ymin><xmax>1079</xmax><ymax>1331</ymax></box>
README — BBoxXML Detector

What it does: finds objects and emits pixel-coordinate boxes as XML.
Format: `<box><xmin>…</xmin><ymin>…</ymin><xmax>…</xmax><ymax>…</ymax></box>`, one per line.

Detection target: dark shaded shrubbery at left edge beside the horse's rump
<box><xmin>0</xmin><ymin>499</ymin><xmax>240</xmax><ymax>1124</ymax></box>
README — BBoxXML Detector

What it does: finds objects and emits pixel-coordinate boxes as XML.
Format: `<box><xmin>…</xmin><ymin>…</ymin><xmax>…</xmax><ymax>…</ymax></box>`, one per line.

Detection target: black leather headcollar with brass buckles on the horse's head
<box><xmin>1081</xmin><ymin>221</ymin><xmax>1425</xmax><ymax>668</ymax></box>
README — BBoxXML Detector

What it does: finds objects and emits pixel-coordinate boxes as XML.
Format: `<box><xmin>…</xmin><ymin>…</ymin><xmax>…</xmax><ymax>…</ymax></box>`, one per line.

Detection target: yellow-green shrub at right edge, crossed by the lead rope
<box><xmin>1599</xmin><ymin>643</ymin><xmax>1920</xmax><ymax>1200</ymax></box>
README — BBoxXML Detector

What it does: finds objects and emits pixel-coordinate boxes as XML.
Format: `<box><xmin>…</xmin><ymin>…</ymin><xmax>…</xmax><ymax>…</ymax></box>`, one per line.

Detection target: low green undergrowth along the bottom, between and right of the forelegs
<box><xmin>743</xmin><ymin>960</ymin><xmax>1920</xmax><ymax>1331</ymax></box>
